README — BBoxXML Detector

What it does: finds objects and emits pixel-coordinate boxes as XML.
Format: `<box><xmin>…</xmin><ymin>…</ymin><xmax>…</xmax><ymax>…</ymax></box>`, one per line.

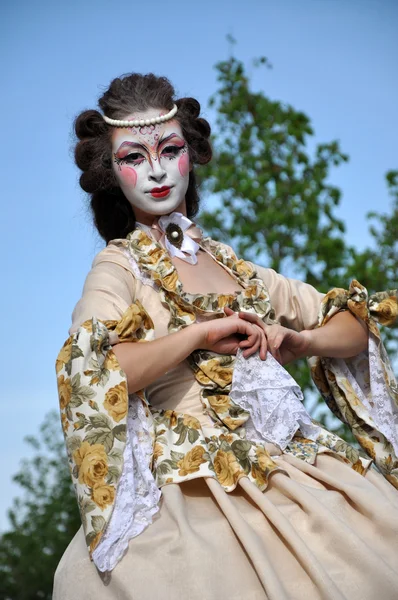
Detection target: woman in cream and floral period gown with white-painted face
<box><xmin>54</xmin><ymin>74</ymin><xmax>398</xmax><ymax>600</ymax></box>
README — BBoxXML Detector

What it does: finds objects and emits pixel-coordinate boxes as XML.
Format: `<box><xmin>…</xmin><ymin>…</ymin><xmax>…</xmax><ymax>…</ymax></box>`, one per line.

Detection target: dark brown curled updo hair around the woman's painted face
<box><xmin>75</xmin><ymin>73</ymin><xmax>212</xmax><ymax>243</ymax></box>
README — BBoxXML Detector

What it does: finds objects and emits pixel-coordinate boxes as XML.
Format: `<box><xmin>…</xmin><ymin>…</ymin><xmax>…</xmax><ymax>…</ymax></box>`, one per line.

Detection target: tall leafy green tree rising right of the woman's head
<box><xmin>197</xmin><ymin>57</ymin><xmax>348</xmax><ymax>408</ymax></box>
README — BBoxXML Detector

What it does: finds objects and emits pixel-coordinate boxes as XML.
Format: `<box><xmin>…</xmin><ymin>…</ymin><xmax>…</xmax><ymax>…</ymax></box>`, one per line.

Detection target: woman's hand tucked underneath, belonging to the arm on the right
<box><xmin>225</xmin><ymin>307</ymin><xmax>310</xmax><ymax>365</ymax></box>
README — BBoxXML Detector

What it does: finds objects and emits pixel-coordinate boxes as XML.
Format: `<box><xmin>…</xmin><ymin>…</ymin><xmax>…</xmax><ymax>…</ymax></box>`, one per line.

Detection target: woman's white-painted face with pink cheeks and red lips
<box><xmin>112</xmin><ymin>109</ymin><xmax>190</xmax><ymax>225</ymax></box>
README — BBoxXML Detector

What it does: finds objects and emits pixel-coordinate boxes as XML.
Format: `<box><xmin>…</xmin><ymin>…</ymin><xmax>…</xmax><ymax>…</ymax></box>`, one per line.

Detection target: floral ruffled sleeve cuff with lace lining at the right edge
<box><xmin>309</xmin><ymin>280</ymin><xmax>398</xmax><ymax>488</ymax></box>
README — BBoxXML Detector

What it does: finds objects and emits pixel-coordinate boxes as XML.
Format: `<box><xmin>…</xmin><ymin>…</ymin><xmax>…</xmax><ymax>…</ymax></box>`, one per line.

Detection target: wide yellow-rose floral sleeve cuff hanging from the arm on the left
<box><xmin>56</xmin><ymin>301</ymin><xmax>153</xmax><ymax>552</ymax></box>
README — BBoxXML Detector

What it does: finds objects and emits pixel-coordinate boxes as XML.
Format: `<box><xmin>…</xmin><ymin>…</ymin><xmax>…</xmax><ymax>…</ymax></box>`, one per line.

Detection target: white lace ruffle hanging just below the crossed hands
<box><xmin>230</xmin><ymin>351</ymin><xmax>320</xmax><ymax>450</ymax></box>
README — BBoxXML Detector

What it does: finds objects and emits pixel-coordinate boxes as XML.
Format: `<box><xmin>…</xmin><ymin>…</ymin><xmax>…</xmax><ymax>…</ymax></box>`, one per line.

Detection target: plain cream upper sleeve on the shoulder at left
<box><xmin>69</xmin><ymin>244</ymin><xmax>135</xmax><ymax>334</ymax></box>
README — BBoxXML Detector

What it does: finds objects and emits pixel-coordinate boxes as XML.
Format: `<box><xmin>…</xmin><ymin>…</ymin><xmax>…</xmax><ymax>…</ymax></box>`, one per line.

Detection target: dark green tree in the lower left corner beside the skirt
<box><xmin>0</xmin><ymin>412</ymin><xmax>80</xmax><ymax>600</ymax></box>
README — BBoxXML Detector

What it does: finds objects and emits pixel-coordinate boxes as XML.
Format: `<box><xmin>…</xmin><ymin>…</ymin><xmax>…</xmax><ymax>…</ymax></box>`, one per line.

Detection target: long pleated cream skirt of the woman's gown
<box><xmin>53</xmin><ymin>454</ymin><xmax>398</xmax><ymax>600</ymax></box>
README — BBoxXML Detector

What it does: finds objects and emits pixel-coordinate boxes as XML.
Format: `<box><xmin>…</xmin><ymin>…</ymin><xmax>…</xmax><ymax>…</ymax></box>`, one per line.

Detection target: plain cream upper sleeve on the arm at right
<box><xmin>253</xmin><ymin>265</ymin><xmax>324</xmax><ymax>331</ymax></box>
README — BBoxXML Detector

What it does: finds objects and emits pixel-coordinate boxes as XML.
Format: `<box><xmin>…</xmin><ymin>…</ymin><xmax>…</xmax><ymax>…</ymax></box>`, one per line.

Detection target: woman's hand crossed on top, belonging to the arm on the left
<box><xmin>197</xmin><ymin>311</ymin><xmax>266</xmax><ymax>359</ymax></box>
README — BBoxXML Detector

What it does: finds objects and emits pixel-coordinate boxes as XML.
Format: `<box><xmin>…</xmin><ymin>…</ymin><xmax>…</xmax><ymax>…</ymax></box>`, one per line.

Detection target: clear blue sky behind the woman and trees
<box><xmin>0</xmin><ymin>0</ymin><xmax>398</xmax><ymax>529</ymax></box>
